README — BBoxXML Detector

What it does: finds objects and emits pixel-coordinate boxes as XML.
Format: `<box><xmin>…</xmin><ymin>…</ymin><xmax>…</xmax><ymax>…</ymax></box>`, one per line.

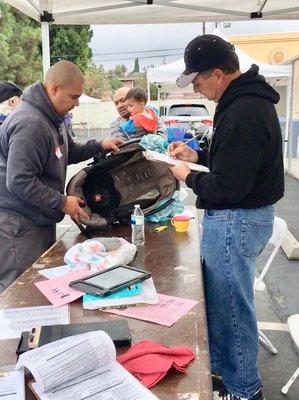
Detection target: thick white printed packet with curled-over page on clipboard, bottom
<box><xmin>16</xmin><ymin>331</ymin><xmax>157</xmax><ymax>400</ymax></box>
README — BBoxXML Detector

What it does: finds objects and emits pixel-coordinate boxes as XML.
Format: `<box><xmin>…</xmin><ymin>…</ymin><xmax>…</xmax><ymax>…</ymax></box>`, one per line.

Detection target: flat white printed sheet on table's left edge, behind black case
<box><xmin>0</xmin><ymin>306</ymin><xmax>70</xmax><ymax>338</ymax></box>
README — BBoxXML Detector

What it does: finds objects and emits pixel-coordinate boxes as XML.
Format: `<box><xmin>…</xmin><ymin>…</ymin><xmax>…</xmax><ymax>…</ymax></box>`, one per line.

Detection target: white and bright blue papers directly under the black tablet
<box><xmin>83</xmin><ymin>278</ymin><xmax>159</xmax><ymax>310</ymax></box>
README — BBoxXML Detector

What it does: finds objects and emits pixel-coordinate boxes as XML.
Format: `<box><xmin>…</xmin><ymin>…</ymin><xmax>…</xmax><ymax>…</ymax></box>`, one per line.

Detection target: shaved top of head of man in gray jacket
<box><xmin>44</xmin><ymin>60</ymin><xmax>84</xmax><ymax>87</ymax></box>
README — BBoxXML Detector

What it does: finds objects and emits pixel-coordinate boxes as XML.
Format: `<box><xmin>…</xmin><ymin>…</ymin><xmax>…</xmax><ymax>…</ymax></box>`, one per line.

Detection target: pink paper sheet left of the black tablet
<box><xmin>35</xmin><ymin>269</ymin><xmax>93</xmax><ymax>307</ymax></box>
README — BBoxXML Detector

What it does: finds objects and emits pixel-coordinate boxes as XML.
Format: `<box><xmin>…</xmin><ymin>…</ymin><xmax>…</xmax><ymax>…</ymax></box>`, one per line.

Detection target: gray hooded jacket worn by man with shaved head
<box><xmin>0</xmin><ymin>82</ymin><xmax>101</xmax><ymax>225</ymax></box>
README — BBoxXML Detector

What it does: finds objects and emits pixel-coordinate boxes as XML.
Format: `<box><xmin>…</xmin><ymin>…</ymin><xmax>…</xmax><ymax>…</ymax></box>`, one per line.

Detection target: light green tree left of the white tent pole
<box><xmin>0</xmin><ymin>1</ymin><xmax>42</xmax><ymax>88</ymax></box>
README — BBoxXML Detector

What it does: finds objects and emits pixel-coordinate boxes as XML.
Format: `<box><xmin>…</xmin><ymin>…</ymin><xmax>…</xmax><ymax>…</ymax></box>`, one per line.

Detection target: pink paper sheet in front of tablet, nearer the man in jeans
<box><xmin>104</xmin><ymin>294</ymin><xmax>198</xmax><ymax>326</ymax></box>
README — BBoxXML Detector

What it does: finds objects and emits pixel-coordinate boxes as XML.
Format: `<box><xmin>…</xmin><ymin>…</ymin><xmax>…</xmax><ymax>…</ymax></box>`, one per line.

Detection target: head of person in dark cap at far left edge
<box><xmin>0</xmin><ymin>81</ymin><xmax>23</xmax><ymax>125</ymax></box>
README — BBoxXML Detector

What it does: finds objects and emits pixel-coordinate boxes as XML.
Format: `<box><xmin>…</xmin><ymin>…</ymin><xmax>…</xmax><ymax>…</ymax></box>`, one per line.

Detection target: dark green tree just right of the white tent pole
<box><xmin>50</xmin><ymin>25</ymin><xmax>93</xmax><ymax>71</ymax></box>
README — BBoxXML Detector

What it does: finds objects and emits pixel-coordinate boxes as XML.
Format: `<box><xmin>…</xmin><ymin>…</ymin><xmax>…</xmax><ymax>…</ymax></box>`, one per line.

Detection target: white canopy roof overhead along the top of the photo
<box><xmin>6</xmin><ymin>0</ymin><xmax>299</xmax><ymax>25</ymax></box>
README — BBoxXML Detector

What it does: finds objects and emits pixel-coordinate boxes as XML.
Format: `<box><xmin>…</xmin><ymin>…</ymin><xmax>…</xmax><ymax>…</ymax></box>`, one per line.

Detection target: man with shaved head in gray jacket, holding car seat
<box><xmin>0</xmin><ymin>61</ymin><xmax>123</xmax><ymax>292</ymax></box>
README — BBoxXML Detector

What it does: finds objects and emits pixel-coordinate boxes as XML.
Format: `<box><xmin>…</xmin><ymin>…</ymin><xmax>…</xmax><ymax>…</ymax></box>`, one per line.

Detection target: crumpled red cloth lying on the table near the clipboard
<box><xmin>117</xmin><ymin>340</ymin><xmax>195</xmax><ymax>387</ymax></box>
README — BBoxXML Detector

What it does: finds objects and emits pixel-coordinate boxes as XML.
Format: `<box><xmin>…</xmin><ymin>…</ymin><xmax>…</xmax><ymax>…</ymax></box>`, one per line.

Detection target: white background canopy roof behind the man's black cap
<box><xmin>147</xmin><ymin>29</ymin><xmax>291</xmax><ymax>83</ymax></box>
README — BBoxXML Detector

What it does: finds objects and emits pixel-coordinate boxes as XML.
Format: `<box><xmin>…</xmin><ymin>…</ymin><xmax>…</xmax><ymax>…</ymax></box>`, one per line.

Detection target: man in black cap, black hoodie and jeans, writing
<box><xmin>170</xmin><ymin>35</ymin><xmax>284</xmax><ymax>400</ymax></box>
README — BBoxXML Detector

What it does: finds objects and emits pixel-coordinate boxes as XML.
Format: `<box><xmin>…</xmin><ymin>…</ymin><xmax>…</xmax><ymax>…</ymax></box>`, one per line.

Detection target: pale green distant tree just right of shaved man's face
<box><xmin>84</xmin><ymin>63</ymin><xmax>111</xmax><ymax>99</ymax></box>
